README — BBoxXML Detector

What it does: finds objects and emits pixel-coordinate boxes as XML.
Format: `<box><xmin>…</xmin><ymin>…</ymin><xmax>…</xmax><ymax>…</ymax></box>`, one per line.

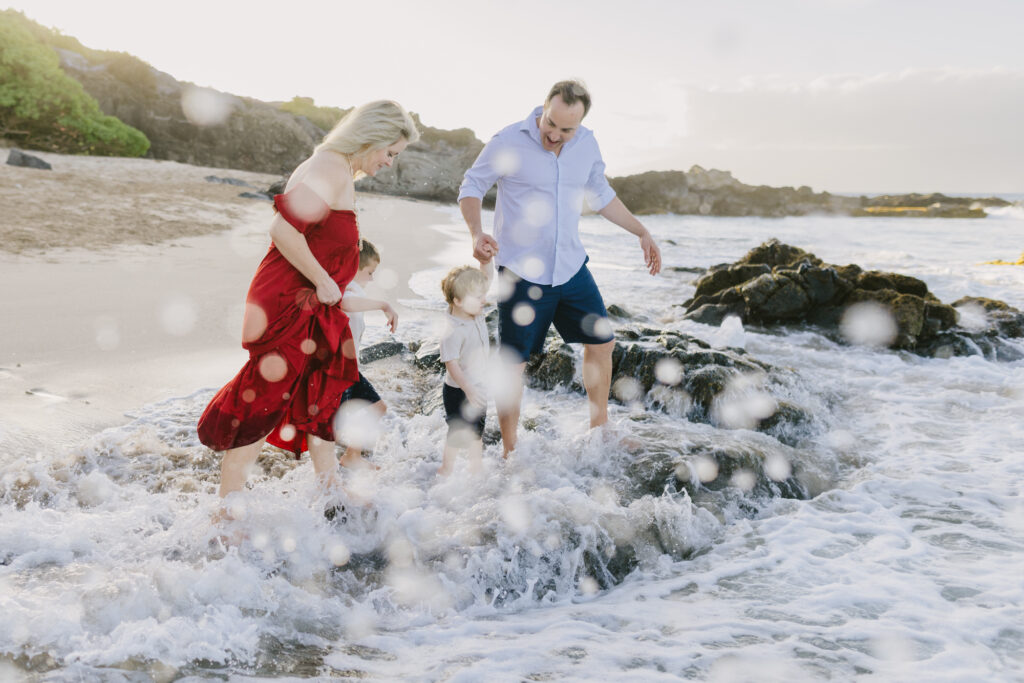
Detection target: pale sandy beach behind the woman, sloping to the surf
<box><xmin>0</xmin><ymin>148</ymin><xmax>453</xmax><ymax>455</ymax></box>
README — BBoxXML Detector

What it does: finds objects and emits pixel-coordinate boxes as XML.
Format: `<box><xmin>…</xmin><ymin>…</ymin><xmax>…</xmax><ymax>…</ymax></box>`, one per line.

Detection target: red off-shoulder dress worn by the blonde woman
<box><xmin>198</xmin><ymin>184</ymin><xmax>359</xmax><ymax>456</ymax></box>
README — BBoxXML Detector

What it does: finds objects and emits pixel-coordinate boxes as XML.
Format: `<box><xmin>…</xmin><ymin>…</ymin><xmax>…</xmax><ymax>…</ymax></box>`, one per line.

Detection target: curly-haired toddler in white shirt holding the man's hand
<box><xmin>437</xmin><ymin>263</ymin><xmax>494</xmax><ymax>476</ymax></box>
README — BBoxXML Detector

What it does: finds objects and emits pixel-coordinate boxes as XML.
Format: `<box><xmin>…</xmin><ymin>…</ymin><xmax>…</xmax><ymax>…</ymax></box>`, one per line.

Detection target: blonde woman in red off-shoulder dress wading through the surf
<box><xmin>198</xmin><ymin>100</ymin><xmax>419</xmax><ymax>507</ymax></box>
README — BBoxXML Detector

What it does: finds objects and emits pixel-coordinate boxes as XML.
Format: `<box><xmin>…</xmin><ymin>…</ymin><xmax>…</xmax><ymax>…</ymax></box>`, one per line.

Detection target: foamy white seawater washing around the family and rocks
<box><xmin>0</xmin><ymin>208</ymin><xmax>1024</xmax><ymax>681</ymax></box>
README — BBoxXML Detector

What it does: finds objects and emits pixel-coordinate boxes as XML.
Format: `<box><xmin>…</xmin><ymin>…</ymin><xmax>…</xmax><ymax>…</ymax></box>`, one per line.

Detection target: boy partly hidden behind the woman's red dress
<box><xmin>341</xmin><ymin>240</ymin><xmax>398</xmax><ymax>467</ymax></box>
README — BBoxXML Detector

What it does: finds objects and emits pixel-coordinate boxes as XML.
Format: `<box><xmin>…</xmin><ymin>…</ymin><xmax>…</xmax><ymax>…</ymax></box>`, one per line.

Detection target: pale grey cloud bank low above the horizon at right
<box><xmin>622</xmin><ymin>69</ymin><xmax>1024</xmax><ymax>191</ymax></box>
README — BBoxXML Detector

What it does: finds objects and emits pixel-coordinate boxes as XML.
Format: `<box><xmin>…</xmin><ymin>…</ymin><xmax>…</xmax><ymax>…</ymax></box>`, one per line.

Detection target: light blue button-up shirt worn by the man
<box><xmin>459</xmin><ymin>106</ymin><xmax>615</xmax><ymax>286</ymax></box>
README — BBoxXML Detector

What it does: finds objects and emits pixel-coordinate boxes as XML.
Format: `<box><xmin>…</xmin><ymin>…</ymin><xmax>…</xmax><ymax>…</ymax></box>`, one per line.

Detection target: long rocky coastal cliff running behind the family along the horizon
<box><xmin>0</xmin><ymin>10</ymin><xmax>1009</xmax><ymax>218</ymax></box>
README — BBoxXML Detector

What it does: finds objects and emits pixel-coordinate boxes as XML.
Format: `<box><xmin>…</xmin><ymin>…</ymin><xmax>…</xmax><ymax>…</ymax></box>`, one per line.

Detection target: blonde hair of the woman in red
<box><xmin>316</xmin><ymin>99</ymin><xmax>420</xmax><ymax>157</ymax></box>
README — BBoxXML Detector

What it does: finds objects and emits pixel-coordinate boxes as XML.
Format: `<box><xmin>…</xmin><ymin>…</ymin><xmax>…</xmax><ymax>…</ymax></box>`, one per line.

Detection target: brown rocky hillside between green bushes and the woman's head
<box><xmin>57</xmin><ymin>49</ymin><xmax>324</xmax><ymax>173</ymax></box>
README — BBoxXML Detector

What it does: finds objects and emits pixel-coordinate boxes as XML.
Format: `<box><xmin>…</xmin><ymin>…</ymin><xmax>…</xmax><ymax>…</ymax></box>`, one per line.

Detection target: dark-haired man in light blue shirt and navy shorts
<box><xmin>459</xmin><ymin>81</ymin><xmax>662</xmax><ymax>457</ymax></box>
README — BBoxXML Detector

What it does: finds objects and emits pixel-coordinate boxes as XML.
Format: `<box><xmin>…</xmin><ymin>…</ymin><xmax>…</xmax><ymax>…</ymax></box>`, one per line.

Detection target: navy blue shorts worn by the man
<box><xmin>498</xmin><ymin>258</ymin><xmax>615</xmax><ymax>360</ymax></box>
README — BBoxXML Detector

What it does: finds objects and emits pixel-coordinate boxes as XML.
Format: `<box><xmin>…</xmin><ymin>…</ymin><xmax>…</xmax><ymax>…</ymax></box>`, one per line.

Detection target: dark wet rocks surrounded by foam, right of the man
<box><xmin>683</xmin><ymin>240</ymin><xmax>1024</xmax><ymax>359</ymax></box>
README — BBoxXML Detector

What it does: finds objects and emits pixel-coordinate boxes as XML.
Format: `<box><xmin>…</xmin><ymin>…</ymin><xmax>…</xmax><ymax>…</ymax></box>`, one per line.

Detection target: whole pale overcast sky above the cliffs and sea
<box><xmin>7</xmin><ymin>0</ymin><xmax>1024</xmax><ymax>193</ymax></box>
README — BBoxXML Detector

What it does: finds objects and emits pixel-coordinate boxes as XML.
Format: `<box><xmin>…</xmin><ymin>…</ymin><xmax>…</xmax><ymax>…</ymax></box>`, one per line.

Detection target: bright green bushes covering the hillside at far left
<box><xmin>0</xmin><ymin>9</ymin><xmax>152</xmax><ymax>157</ymax></box>
